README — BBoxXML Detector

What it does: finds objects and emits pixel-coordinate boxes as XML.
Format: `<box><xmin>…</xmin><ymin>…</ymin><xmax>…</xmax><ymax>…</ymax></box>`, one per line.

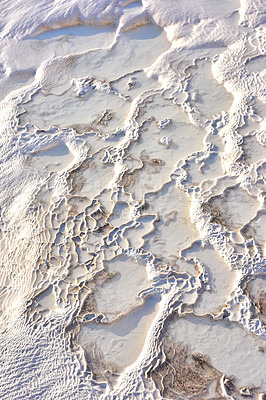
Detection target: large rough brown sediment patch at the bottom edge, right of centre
<box><xmin>150</xmin><ymin>336</ymin><xmax>222</xmax><ymax>400</ymax></box>
